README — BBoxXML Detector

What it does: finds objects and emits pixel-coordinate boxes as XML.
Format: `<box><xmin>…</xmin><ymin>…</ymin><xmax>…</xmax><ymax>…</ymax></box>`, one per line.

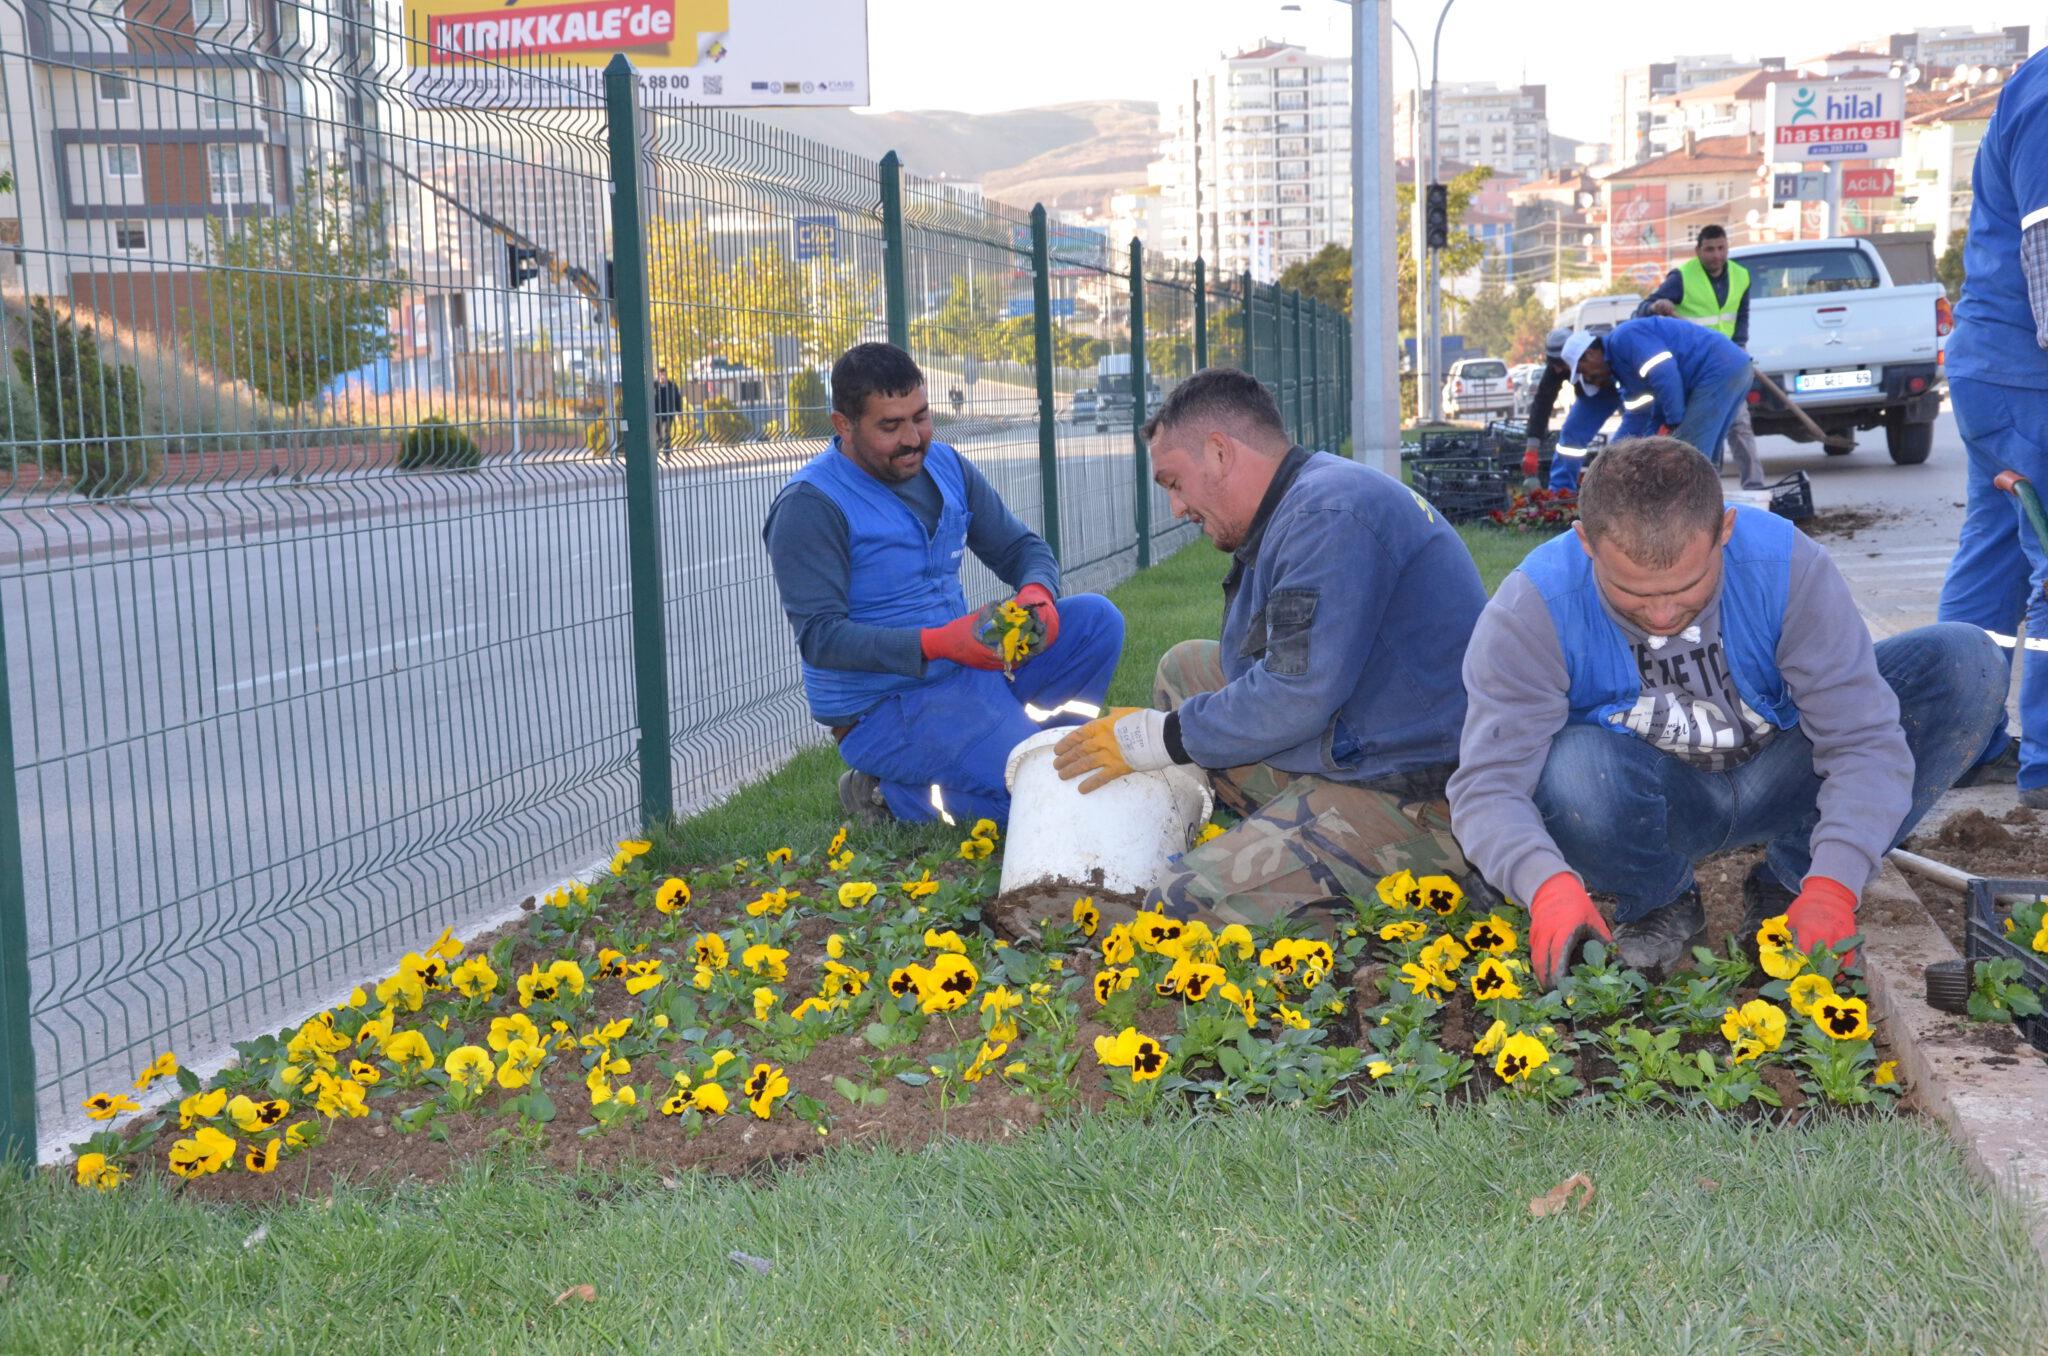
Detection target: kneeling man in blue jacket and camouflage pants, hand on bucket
<box><xmin>1055</xmin><ymin>369</ymin><xmax>1487</xmax><ymax>926</ymax></box>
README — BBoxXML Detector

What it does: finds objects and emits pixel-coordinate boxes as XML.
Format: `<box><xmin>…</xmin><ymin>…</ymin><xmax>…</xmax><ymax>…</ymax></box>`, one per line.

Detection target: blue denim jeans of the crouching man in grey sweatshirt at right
<box><xmin>1536</xmin><ymin>625</ymin><xmax>2007</xmax><ymax>922</ymax></box>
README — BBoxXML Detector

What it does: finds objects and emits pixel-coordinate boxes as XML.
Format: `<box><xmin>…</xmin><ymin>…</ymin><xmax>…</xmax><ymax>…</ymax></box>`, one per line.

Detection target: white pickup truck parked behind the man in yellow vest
<box><xmin>1731</xmin><ymin>238</ymin><xmax>1954</xmax><ymax>465</ymax></box>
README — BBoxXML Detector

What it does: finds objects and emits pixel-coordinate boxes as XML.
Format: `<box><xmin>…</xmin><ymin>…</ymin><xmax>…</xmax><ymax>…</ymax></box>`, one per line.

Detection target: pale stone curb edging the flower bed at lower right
<box><xmin>1858</xmin><ymin>862</ymin><xmax>2048</xmax><ymax>1262</ymax></box>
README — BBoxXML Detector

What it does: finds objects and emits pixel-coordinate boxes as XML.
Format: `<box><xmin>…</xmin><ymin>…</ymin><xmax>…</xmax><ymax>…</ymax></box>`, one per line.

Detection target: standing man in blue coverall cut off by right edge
<box><xmin>1939</xmin><ymin>55</ymin><xmax>2048</xmax><ymax>809</ymax></box>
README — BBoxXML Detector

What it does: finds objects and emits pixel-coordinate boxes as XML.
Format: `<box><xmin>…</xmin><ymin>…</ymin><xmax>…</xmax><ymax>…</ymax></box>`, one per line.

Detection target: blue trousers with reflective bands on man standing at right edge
<box><xmin>1937</xmin><ymin>377</ymin><xmax>2048</xmax><ymax>791</ymax></box>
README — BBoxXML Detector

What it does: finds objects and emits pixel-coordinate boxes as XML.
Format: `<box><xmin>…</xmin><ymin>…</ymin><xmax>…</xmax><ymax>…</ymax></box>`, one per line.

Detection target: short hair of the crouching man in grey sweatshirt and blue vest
<box><xmin>1579</xmin><ymin>438</ymin><xmax>1726</xmax><ymax>569</ymax></box>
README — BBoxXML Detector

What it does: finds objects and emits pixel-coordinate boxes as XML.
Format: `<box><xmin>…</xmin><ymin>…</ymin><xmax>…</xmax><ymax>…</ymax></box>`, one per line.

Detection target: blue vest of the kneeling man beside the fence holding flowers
<box><xmin>791</xmin><ymin>438</ymin><xmax>969</xmax><ymax>721</ymax></box>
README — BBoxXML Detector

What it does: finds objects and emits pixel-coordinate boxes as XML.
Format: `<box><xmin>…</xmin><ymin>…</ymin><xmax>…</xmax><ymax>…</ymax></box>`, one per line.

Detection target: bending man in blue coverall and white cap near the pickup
<box><xmin>1552</xmin><ymin>315</ymin><xmax>1751</xmax><ymax>483</ymax></box>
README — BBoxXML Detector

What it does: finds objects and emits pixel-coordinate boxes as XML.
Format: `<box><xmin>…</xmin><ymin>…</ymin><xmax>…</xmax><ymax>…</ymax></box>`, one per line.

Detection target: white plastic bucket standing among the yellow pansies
<box><xmin>1001</xmin><ymin>725</ymin><xmax>1212</xmax><ymax>909</ymax></box>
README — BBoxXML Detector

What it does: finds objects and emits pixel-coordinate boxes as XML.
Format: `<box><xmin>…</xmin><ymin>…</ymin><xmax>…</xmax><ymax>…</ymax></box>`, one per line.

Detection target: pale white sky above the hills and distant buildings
<box><xmin>868</xmin><ymin>0</ymin><xmax>2048</xmax><ymax>141</ymax></box>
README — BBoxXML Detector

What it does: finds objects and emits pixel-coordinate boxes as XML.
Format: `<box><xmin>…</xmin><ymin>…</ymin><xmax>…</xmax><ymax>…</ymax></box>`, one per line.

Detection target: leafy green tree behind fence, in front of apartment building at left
<box><xmin>193</xmin><ymin>160</ymin><xmax>406</xmax><ymax>406</ymax></box>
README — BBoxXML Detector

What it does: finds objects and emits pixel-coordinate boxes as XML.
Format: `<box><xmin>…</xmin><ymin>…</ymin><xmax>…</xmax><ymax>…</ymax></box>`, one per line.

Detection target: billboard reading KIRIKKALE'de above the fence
<box><xmin>406</xmin><ymin>0</ymin><xmax>868</xmax><ymax>109</ymax></box>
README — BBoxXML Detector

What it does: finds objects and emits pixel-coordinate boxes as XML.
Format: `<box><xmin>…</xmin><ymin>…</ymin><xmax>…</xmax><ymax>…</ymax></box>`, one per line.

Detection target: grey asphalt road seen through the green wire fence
<box><xmin>0</xmin><ymin>411</ymin><xmax>1184</xmax><ymax>1143</ymax></box>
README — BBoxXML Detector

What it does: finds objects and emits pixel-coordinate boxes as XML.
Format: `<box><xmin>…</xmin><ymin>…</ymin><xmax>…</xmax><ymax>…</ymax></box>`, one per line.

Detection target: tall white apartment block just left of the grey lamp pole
<box><xmin>1151</xmin><ymin>43</ymin><xmax>1352</xmax><ymax>277</ymax></box>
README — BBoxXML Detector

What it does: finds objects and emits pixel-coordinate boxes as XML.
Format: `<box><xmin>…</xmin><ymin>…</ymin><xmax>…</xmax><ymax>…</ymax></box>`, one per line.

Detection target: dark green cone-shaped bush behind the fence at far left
<box><xmin>14</xmin><ymin>299</ymin><xmax>158</xmax><ymax>498</ymax></box>
